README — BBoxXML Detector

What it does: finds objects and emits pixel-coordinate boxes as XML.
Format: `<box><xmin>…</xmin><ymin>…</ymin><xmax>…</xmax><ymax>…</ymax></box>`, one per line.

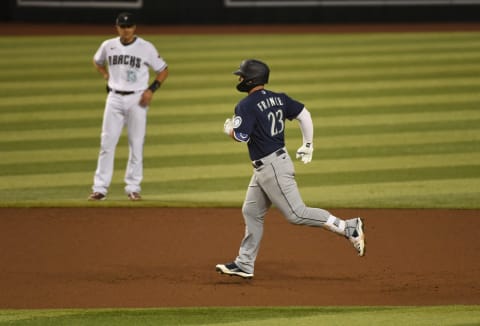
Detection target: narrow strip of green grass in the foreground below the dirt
<box><xmin>0</xmin><ymin>306</ymin><xmax>480</xmax><ymax>326</ymax></box>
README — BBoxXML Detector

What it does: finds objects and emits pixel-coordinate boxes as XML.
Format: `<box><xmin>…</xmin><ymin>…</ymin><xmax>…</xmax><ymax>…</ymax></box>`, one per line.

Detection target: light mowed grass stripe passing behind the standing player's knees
<box><xmin>0</xmin><ymin>122</ymin><xmax>480</xmax><ymax>166</ymax></box>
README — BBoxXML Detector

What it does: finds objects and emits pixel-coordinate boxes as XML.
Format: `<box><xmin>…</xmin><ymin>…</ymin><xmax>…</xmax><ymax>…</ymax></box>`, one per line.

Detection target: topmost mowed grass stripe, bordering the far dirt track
<box><xmin>0</xmin><ymin>30</ymin><xmax>480</xmax><ymax>54</ymax></box>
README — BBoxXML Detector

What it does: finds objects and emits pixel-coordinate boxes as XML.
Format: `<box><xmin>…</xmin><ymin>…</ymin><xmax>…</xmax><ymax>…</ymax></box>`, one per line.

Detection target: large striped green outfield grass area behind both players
<box><xmin>0</xmin><ymin>32</ymin><xmax>480</xmax><ymax>208</ymax></box>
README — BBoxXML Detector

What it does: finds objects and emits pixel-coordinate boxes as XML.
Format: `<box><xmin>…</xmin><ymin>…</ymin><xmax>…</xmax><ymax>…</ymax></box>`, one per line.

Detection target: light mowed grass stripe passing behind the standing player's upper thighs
<box><xmin>0</xmin><ymin>91</ymin><xmax>480</xmax><ymax>123</ymax></box>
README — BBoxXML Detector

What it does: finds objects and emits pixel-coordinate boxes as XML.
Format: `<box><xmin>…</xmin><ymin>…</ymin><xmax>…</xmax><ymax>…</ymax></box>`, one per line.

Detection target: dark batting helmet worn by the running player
<box><xmin>233</xmin><ymin>59</ymin><xmax>270</xmax><ymax>92</ymax></box>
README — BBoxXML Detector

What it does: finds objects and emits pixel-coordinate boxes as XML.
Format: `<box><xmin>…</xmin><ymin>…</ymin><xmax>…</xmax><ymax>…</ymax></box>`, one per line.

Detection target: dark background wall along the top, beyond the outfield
<box><xmin>0</xmin><ymin>0</ymin><xmax>480</xmax><ymax>25</ymax></box>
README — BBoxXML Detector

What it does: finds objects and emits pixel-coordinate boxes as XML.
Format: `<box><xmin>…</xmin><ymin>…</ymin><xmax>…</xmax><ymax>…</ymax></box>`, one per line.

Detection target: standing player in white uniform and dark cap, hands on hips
<box><xmin>88</xmin><ymin>13</ymin><xmax>168</xmax><ymax>200</ymax></box>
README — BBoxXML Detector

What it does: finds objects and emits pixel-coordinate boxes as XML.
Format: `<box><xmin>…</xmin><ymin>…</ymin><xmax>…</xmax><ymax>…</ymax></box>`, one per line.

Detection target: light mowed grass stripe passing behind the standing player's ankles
<box><xmin>0</xmin><ymin>165</ymin><xmax>480</xmax><ymax>198</ymax></box>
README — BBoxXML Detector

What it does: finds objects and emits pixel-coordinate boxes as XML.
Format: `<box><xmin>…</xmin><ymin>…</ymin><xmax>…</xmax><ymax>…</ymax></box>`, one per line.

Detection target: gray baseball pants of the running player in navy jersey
<box><xmin>235</xmin><ymin>150</ymin><xmax>356</xmax><ymax>273</ymax></box>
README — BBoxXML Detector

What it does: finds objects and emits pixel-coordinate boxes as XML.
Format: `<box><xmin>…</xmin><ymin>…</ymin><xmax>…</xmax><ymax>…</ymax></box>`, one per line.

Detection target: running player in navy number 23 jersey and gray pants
<box><xmin>216</xmin><ymin>59</ymin><xmax>365</xmax><ymax>279</ymax></box>
